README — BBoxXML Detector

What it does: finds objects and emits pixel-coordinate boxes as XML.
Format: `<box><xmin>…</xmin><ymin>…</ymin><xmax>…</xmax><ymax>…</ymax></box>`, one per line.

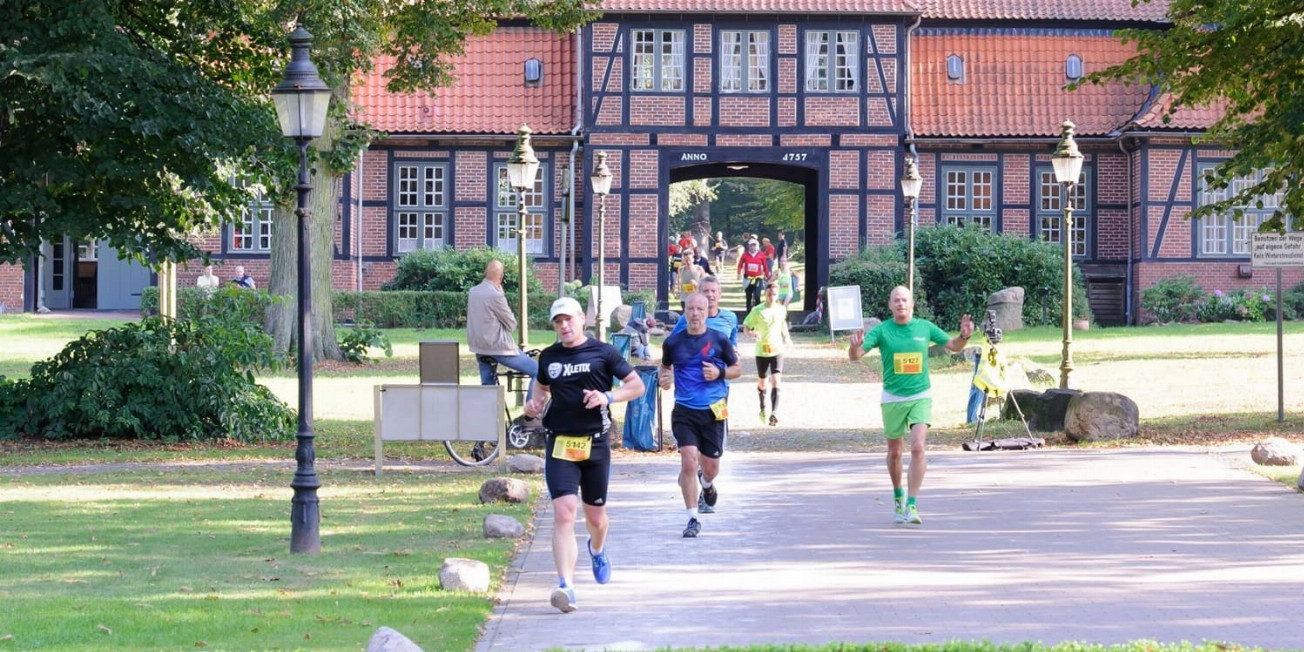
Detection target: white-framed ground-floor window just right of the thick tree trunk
<box><xmin>391</xmin><ymin>162</ymin><xmax>449</xmax><ymax>256</ymax></box>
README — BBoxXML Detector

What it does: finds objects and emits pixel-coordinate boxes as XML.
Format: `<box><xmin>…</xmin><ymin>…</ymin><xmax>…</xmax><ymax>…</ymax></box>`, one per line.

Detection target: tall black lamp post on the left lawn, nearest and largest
<box><xmin>271</xmin><ymin>23</ymin><xmax>331</xmax><ymax>554</ymax></box>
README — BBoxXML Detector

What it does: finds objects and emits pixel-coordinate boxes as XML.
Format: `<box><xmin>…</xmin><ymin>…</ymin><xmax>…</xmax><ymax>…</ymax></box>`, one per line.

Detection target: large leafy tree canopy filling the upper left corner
<box><xmin>0</xmin><ymin>0</ymin><xmax>591</xmax><ymax>263</ymax></box>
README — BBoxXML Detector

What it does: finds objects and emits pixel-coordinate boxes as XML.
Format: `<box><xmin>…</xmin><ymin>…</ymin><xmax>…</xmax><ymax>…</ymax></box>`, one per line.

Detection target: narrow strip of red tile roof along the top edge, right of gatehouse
<box><xmin>914</xmin><ymin>0</ymin><xmax>1168</xmax><ymax>22</ymax></box>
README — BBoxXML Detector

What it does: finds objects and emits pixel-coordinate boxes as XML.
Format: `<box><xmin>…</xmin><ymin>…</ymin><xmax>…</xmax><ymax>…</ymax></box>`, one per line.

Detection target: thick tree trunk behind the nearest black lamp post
<box><xmin>265</xmin><ymin>116</ymin><xmax>343</xmax><ymax>360</ymax></box>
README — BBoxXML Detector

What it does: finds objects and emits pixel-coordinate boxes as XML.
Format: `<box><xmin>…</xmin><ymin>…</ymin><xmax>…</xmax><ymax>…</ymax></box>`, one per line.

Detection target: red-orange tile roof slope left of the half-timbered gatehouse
<box><xmin>352</xmin><ymin>27</ymin><xmax>575</xmax><ymax>134</ymax></box>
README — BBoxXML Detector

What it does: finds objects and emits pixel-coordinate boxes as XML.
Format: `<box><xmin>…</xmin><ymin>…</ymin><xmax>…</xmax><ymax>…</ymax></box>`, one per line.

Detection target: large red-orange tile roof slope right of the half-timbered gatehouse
<box><xmin>910</xmin><ymin>29</ymin><xmax>1149</xmax><ymax>138</ymax></box>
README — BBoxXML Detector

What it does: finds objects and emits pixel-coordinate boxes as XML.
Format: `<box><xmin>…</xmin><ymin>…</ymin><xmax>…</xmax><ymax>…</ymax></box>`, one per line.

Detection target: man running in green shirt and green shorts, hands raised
<box><xmin>848</xmin><ymin>286</ymin><xmax>974</xmax><ymax>523</ymax></box>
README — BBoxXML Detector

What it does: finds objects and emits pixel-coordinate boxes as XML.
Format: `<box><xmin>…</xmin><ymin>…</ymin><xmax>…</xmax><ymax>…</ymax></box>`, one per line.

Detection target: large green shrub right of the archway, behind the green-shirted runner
<box><xmin>915</xmin><ymin>226</ymin><xmax>1090</xmax><ymax>327</ymax></box>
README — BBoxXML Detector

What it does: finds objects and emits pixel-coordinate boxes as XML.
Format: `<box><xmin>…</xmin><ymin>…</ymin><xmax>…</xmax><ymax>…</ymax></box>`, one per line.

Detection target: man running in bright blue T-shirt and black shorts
<box><xmin>657</xmin><ymin>293</ymin><xmax>742</xmax><ymax>539</ymax></box>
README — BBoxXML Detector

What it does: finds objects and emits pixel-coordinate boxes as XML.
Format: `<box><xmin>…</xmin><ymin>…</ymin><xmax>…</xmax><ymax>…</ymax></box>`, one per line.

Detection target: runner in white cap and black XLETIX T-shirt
<box><xmin>526</xmin><ymin>297</ymin><xmax>643</xmax><ymax>613</ymax></box>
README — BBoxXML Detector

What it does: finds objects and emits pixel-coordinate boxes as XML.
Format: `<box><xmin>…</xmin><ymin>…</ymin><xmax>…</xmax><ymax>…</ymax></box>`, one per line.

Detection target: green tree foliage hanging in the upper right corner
<box><xmin>1086</xmin><ymin>0</ymin><xmax>1304</xmax><ymax>230</ymax></box>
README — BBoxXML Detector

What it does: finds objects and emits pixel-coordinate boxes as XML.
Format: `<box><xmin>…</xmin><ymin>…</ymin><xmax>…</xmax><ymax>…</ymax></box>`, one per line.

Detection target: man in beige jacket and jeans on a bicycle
<box><xmin>467</xmin><ymin>261</ymin><xmax>539</xmax><ymax>400</ymax></box>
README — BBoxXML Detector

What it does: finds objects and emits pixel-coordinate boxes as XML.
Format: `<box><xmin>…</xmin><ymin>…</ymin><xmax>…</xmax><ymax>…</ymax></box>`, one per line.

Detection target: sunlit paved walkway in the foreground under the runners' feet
<box><xmin>477</xmin><ymin>449</ymin><xmax>1304</xmax><ymax>652</ymax></box>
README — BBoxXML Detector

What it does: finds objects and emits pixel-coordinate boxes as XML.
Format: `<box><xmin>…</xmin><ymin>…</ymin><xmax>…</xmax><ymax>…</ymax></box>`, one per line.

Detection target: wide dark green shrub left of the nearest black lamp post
<box><xmin>4</xmin><ymin>314</ymin><xmax>295</xmax><ymax>441</ymax></box>
